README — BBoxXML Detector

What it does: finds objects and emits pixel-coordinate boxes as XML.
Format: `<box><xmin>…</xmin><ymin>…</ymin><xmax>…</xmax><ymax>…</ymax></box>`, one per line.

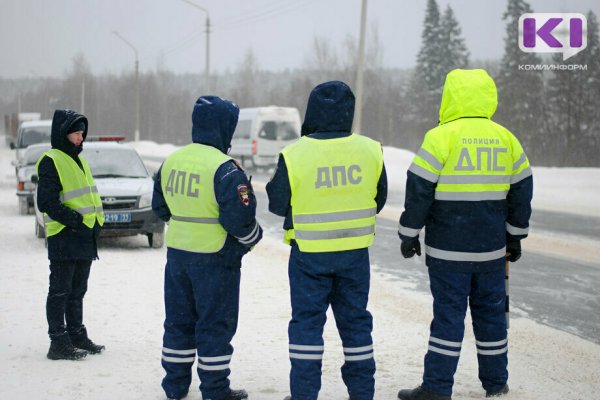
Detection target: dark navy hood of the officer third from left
<box><xmin>302</xmin><ymin>81</ymin><xmax>354</xmax><ymax>136</ymax></box>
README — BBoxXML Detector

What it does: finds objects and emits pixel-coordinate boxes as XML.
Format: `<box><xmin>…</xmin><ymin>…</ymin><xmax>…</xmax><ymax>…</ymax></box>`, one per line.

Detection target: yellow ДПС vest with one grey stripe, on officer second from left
<box><xmin>160</xmin><ymin>143</ymin><xmax>231</xmax><ymax>253</ymax></box>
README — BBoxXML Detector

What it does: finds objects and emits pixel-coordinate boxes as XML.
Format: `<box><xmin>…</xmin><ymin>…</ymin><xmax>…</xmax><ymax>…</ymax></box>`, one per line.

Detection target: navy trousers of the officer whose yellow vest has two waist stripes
<box><xmin>288</xmin><ymin>244</ymin><xmax>375</xmax><ymax>400</ymax></box>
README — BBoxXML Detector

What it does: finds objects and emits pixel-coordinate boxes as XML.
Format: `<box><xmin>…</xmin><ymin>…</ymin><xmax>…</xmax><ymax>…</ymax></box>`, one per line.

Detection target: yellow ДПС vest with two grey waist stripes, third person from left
<box><xmin>281</xmin><ymin>134</ymin><xmax>383</xmax><ymax>253</ymax></box>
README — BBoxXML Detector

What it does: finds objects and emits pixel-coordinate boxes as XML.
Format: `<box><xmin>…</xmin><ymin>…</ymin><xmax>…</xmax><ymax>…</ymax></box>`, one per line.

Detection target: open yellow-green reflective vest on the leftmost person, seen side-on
<box><xmin>36</xmin><ymin>149</ymin><xmax>104</xmax><ymax>237</ymax></box>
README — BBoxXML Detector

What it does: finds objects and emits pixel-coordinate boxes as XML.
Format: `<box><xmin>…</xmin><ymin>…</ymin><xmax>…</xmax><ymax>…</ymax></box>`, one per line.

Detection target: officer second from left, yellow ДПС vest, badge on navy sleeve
<box><xmin>152</xmin><ymin>96</ymin><xmax>262</xmax><ymax>400</ymax></box>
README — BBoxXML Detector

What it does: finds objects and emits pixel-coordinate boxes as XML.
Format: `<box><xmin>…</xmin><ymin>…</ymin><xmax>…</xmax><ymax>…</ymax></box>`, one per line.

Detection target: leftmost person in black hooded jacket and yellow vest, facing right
<box><xmin>36</xmin><ymin>110</ymin><xmax>104</xmax><ymax>360</ymax></box>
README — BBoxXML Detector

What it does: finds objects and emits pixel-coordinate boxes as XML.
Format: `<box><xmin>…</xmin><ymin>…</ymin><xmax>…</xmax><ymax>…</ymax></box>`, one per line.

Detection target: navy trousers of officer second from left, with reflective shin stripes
<box><xmin>162</xmin><ymin>255</ymin><xmax>240</xmax><ymax>400</ymax></box>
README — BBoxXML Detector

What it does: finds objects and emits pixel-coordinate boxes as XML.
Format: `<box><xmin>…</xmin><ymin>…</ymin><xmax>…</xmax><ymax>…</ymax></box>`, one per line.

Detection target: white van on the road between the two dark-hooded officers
<box><xmin>229</xmin><ymin>106</ymin><xmax>300</xmax><ymax>167</ymax></box>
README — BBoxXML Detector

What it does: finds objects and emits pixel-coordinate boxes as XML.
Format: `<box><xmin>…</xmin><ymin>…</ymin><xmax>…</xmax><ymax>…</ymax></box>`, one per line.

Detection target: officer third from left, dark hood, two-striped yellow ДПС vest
<box><xmin>267</xmin><ymin>81</ymin><xmax>387</xmax><ymax>400</ymax></box>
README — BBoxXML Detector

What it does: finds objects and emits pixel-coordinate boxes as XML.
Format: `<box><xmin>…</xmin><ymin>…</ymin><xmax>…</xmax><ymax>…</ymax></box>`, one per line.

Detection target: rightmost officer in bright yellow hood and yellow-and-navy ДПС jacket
<box><xmin>398</xmin><ymin>69</ymin><xmax>533</xmax><ymax>400</ymax></box>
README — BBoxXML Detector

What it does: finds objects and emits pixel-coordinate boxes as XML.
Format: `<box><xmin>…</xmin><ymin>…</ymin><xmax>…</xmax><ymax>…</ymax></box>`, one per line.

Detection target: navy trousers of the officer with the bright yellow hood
<box><xmin>422</xmin><ymin>268</ymin><xmax>508</xmax><ymax>396</ymax></box>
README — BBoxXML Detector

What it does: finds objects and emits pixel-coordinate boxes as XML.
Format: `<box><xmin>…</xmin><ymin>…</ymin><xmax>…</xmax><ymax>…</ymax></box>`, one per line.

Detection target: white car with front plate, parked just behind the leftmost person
<box><xmin>34</xmin><ymin>141</ymin><xmax>165</xmax><ymax>248</ymax></box>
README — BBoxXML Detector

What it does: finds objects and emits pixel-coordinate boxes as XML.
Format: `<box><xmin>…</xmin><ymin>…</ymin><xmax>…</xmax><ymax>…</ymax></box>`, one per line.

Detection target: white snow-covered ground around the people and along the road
<box><xmin>0</xmin><ymin>141</ymin><xmax>600</xmax><ymax>400</ymax></box>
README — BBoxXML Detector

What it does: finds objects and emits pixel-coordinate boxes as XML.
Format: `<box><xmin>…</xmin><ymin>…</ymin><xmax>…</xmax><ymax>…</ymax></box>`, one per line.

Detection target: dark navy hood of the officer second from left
<box><xmin>192</xmin><ymin>96</ymin><xmax>240</xmax><ymax>154</ymax></box>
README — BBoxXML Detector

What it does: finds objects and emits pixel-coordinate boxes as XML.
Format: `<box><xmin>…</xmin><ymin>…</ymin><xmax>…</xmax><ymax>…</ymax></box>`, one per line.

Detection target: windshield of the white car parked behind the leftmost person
<box><xmin>82</xmin><ymin>145</ymin><xmax>148</xmax><ymax>178</ymax></box>
